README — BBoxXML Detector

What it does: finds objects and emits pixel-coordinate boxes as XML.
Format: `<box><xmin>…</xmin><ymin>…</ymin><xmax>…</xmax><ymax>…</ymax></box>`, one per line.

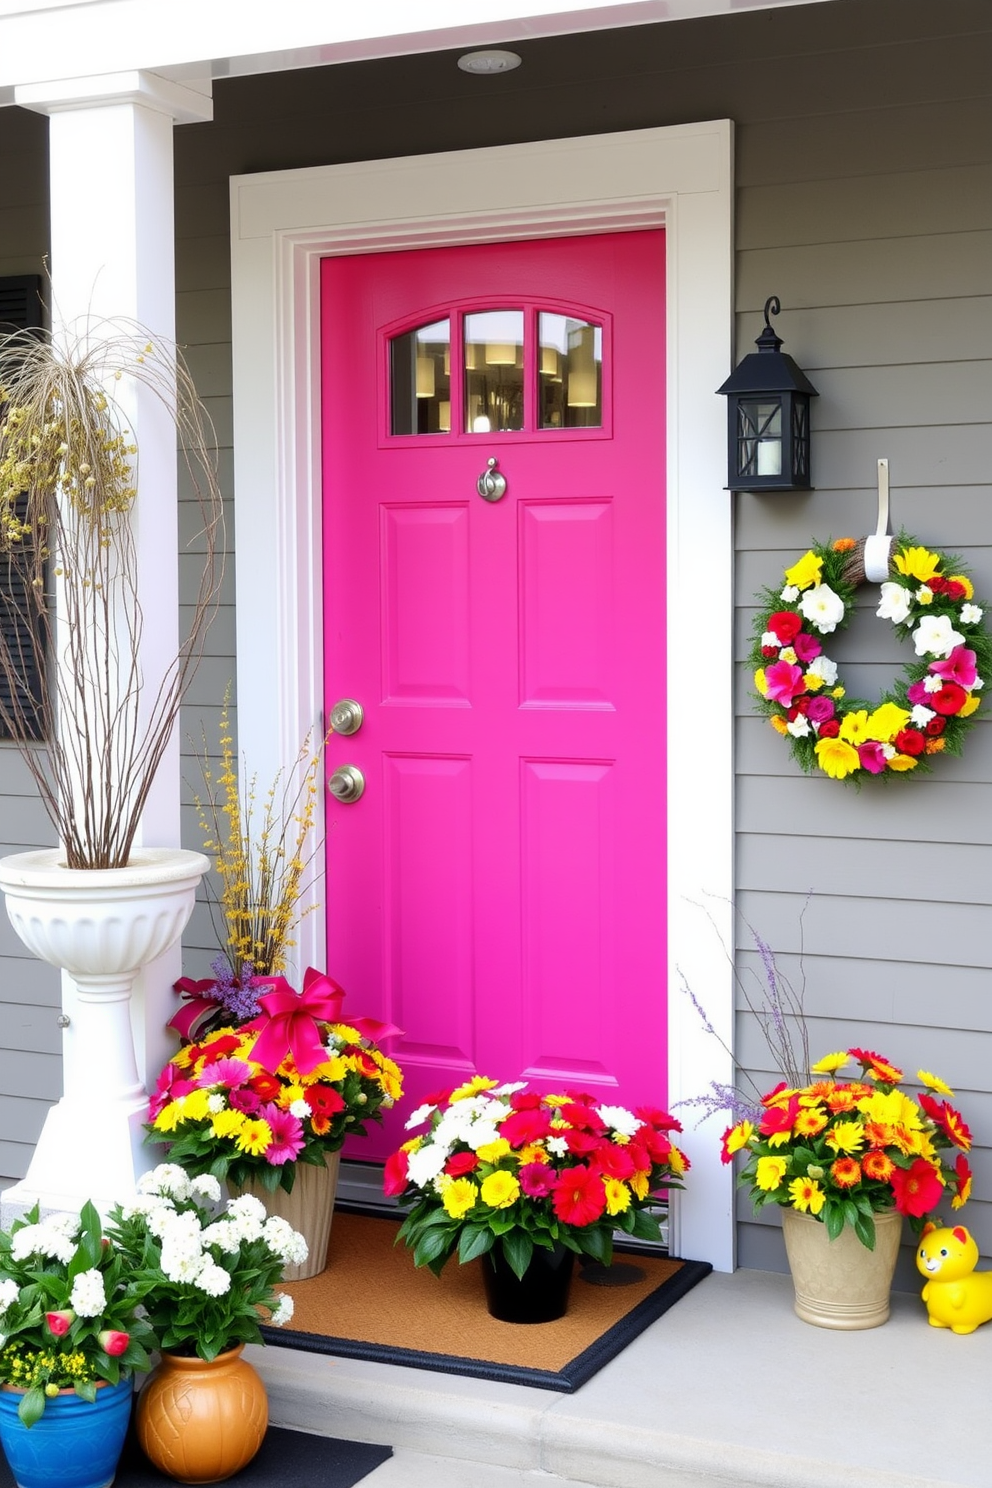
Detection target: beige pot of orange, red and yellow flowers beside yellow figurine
<box><xmin>723</xmin><ymin>1048</ymin><xmax>971</xmax><ymax>1327</ymax></box>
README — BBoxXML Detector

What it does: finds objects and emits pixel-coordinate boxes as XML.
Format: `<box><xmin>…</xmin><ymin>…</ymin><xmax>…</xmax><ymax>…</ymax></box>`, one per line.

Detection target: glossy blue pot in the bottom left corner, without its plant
<box><xmin>0</xmin><ymin>1379</ymin><xmax>134</xmax><ymax>1488</ymax></box>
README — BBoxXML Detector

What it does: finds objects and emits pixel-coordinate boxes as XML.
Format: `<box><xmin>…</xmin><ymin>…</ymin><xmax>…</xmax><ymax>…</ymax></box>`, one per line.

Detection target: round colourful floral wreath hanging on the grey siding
<box><xmin>750</xmin><ymin>534</ymin><xmax>992</xmax><ymax>786</ymax></box>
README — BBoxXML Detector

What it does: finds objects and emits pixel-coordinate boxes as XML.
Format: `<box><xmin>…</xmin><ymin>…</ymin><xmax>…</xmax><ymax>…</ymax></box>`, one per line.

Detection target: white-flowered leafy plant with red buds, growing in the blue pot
<box><xmin>0</xmin><ymin>1202</ymin><xmax>156</xmax><ymax>1427</ymax></box>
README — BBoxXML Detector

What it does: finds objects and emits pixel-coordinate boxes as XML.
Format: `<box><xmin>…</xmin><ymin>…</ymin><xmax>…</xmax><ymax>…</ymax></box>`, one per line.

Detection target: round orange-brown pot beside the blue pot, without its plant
<box><xmin>135</xmin><ymin>1344</ymin><xmax>269</xmax><ymax>1484</ymax></box>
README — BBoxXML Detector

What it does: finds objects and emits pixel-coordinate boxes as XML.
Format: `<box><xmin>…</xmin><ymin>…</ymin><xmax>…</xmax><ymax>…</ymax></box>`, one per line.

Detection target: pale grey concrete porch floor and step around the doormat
<box><xmin>245</xmin><ymin>1271</ymin><xmax>992</xmax><ymax>1488</ymax></box>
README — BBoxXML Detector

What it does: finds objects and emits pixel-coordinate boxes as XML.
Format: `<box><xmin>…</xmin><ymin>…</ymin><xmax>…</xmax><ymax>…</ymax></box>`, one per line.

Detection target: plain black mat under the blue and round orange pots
<box><xmin>0</xmin><ymin>1426</ymin><xmax>393</xmax><ymax>1488</ymax></box>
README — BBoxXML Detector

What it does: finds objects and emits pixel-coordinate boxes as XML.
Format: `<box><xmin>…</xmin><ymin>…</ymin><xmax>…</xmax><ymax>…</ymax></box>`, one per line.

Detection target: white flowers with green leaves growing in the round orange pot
<box><xmin>107</xmin><ymin>1162</ymin><xmax>306</xmax><ymax>1359</ymax></box>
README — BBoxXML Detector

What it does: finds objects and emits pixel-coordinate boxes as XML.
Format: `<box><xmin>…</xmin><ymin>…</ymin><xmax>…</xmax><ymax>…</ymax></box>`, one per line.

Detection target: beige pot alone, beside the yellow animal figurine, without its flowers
<box><xmin>782</xmin><ymin>1208</ymin><xmax>903</xmax><ymax>1329</ymax></box>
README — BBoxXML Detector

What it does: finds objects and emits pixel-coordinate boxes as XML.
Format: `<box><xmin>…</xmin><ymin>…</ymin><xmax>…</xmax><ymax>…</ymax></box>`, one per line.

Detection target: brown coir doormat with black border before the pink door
<box><xmin>263</xmin><ymin>1210</ymin><xmax>712</xmax><ymax>1393</ymax></box>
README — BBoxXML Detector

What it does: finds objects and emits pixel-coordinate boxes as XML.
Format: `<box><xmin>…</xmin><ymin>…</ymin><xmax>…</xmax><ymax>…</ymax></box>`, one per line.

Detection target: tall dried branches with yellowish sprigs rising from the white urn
<box><xmin>0</xmin><ymin>323</ymin><xmax>223</xmax><ymax>868</ymax></box>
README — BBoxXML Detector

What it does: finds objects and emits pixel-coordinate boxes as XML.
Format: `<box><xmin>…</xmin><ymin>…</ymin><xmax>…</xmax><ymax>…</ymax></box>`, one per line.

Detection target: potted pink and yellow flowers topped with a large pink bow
<box><xmin>147</xmin><ymin>969</ymin><xmax>403</xmax><ymax>1281</ymax></box>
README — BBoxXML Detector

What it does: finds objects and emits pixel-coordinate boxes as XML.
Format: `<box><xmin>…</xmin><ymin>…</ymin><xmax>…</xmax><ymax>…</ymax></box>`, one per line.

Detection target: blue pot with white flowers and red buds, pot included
<box><xmin>0</xmin><ymin>1202</ymin><xmax>156</xmax><ymax>1488</ymax></box>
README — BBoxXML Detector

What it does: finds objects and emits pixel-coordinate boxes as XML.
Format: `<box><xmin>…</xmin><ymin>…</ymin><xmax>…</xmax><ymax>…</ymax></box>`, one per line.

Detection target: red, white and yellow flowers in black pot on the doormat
<box><xmin>384</xmin><ymin>1076</ymin><xmax>689</xmax><ymax>1321</ymax></box>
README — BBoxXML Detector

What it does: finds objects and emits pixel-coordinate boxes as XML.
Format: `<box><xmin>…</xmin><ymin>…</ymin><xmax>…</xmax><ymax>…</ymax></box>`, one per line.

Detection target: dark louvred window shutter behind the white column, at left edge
<box><xmin>0</xmin><ymin>274</ymin><xmax>45</xmax><ymax>738</ymax></box>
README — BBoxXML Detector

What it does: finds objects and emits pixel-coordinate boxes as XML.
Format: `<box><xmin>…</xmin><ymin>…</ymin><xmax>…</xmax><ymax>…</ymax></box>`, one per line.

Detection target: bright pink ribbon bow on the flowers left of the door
<box><xmin>247</xmin><ymin>966</ymin><xmax>402</xmax><ymax>1074</ymax></box>
